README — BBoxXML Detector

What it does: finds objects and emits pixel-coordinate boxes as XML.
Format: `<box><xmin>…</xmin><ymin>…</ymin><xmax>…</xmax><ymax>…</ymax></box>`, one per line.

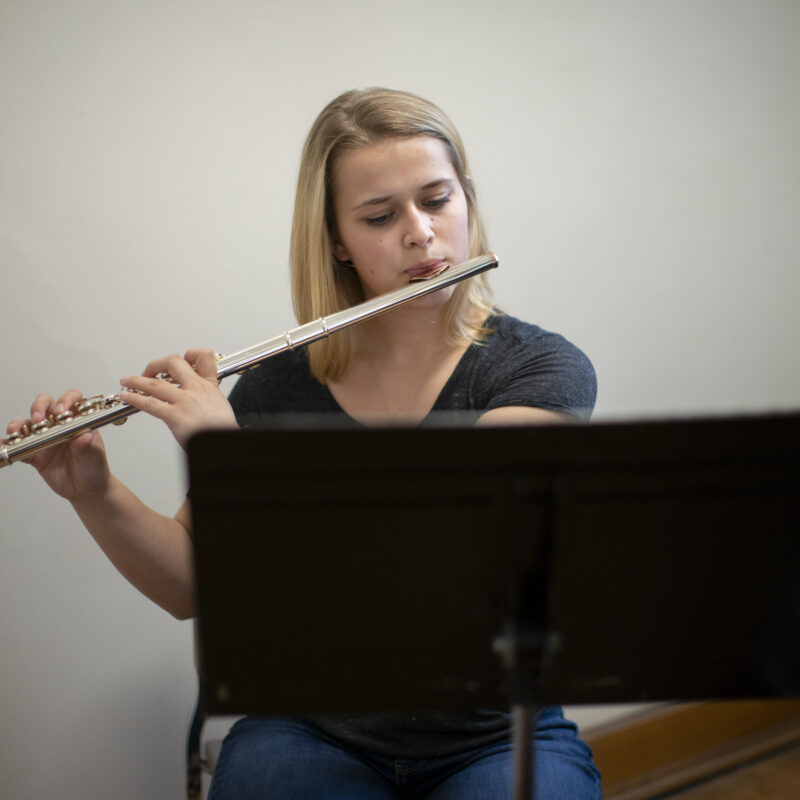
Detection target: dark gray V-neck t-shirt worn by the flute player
<box><xmin>225</xmin><ymin>315</ymin><xmax>597</xmax><ymax>758</ymax></box>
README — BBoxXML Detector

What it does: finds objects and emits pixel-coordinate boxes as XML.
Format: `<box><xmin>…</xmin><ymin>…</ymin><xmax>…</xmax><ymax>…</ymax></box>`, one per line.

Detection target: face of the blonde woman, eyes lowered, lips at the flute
<box><xmin>333</xmin><ymin>136</ymin><xmax>469</xmax><ymax>305</ymax></box>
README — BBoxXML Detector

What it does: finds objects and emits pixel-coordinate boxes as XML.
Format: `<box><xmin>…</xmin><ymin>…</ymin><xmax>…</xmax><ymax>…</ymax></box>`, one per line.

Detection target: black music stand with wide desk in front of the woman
<box><xmin>189</xmin><ymin>415</ymin><xmax>800</xmax><ymax>797</ymax></box>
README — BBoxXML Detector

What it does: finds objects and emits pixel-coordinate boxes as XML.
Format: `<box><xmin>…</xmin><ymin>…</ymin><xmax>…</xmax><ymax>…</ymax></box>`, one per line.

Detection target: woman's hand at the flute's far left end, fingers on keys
<box><xmin>6</xmin><ymin>389</ymin><xmax>111</xmax><ymax>500</ymax></box>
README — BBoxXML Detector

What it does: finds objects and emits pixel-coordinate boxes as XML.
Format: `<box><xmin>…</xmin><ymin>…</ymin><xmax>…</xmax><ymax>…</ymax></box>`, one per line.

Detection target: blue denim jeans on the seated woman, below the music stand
<box><xmin>209</xmin><ymin>708</ymin><xmax>601</xmax><ymax>800</ymax></box>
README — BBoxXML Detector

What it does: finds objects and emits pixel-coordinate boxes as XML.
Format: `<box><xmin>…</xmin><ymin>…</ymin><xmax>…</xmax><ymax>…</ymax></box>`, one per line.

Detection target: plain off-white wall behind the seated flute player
<box><xmin>0</xmin><ymin>0</ymin><xmax>800</xmax><ymax>800</ymax></box>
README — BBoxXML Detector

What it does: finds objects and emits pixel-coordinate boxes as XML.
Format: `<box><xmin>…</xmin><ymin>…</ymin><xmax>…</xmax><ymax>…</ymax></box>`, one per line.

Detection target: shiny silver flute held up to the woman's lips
<box><xmin>0</xmin><ymin>253</ymin><xmax>498</xmax><ymax>467</ymax></box>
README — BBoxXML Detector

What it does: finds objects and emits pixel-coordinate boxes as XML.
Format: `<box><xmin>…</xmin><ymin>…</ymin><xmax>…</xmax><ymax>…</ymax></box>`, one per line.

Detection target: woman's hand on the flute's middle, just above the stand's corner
<box><xmin>120</xmin><ymin>348</ymin><xmax>238</xmax><ymax>450</ymax></box>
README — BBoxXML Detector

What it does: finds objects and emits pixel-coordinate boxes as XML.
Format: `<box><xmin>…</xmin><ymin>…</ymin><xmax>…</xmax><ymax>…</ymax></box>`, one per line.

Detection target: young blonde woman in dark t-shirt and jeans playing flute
<box><xmin>8</xmin><ymin>89</ymin><xmax>600</xmax><ymax>800</ymax></box>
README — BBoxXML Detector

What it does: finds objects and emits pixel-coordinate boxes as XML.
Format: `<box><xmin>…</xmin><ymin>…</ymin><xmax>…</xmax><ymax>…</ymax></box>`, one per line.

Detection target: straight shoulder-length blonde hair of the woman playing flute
<box><xmin>289</xmin><ymin>89</ymin><xmax>492</xmax><ymax>383</ymax></box>
